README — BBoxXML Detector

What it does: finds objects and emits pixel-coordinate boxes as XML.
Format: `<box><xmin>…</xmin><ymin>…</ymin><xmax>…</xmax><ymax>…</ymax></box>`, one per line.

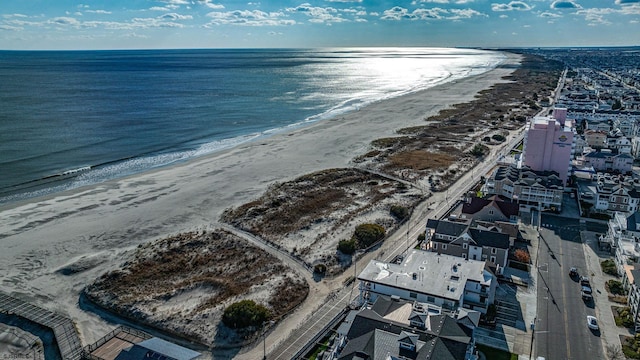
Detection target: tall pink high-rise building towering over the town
<box><xmin>524</xmin><ymin>108</ymin><xmax>575</xmax><ymax>185</ymax></box>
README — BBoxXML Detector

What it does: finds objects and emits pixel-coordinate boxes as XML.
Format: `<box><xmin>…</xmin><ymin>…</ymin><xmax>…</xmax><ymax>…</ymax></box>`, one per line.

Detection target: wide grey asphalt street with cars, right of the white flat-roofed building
<box><xmin>534</xmin><ymin>215</ymin><xmax>604</xmax><ymax>360</ymax></box>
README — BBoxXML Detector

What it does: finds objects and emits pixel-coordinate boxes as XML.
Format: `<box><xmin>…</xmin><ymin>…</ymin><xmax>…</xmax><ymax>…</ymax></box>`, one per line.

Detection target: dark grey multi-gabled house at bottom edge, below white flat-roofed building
<box><xmin>332</xmin><ymin>296</ymin><xmax>480</xmax><ymax>360</ymax></box>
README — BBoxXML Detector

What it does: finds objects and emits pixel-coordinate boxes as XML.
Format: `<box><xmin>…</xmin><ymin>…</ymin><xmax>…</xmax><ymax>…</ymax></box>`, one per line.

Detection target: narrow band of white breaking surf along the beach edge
<box><xmin>0</xmin><ymin>50</ymin><xmax>506</xmax><ymax>211</ymax></box>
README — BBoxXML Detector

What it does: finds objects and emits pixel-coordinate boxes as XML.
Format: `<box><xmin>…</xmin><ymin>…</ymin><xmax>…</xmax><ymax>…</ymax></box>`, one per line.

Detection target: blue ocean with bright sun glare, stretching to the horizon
<box><xmin>0</xmin><ymin>48</ymin><xmax>504</xmax><ymax>204</ymax></box>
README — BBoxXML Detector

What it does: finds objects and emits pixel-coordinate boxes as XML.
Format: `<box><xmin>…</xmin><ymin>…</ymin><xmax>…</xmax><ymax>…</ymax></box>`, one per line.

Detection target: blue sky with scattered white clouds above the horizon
<box><xmin>0</xmin><ymin>0</ymin><xmax>640</xmax><ymax>50</ymax></box>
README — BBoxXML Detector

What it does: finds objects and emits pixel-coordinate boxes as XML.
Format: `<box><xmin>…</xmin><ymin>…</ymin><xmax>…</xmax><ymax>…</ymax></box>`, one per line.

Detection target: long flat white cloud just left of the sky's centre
<box><xmin>205</xmin><ymin>10</ymin><xmax>296</xmax><ymax>27</ymax></box>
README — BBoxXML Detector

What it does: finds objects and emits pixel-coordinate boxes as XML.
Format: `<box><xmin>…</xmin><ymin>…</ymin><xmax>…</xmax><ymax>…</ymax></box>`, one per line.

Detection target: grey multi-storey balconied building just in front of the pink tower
<box><xmin>482</xmin><ymin>166</ymin><xmax>564</xmax><ymax>211</ymax></box>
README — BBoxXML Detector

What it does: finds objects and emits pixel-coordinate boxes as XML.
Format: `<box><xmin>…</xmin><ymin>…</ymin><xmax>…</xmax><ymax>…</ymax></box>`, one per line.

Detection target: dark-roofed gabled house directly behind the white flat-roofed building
<box><xmin>425</xmin><ymin>219</ymin><xmax>513</xmax><ymax>272</ymax></box>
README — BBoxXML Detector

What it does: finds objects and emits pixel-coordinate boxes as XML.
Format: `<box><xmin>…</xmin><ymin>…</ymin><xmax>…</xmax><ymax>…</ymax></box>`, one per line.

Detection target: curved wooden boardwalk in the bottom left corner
<box><xmin>0</xmin><ymin>292</ymin><xmax>82</xmax><ymax>360</ymax></box>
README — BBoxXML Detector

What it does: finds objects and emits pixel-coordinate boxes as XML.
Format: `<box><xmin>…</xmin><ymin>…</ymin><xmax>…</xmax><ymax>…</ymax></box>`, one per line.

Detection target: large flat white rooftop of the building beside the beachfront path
<box><xmin>358</xmin><ymin>250</ymin><xmax>492</xmax><ymax>300</ymax></box>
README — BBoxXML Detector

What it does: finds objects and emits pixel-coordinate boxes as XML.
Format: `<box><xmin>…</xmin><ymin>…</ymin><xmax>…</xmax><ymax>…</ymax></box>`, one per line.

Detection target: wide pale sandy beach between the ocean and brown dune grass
<box><xmin>0</xmin><ymin>54</ymin><xmax>520</xmax><ymax>358</ymax></box>
